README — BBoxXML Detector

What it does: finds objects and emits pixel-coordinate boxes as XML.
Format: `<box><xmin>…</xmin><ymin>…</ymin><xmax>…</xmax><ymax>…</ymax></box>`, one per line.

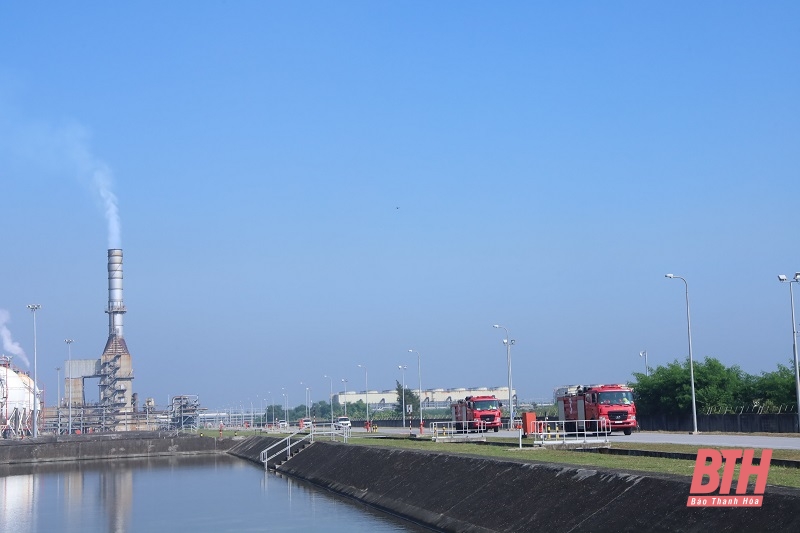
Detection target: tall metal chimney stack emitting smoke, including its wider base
<box><xmin>99</xmin><ymin>249</ymin><xmax>136</xmax><ymax>431</ymax></box>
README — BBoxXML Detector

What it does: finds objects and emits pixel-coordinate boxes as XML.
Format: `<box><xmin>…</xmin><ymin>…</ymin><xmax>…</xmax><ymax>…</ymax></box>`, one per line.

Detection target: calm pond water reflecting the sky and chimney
<box><xmin>0</xmin><ymin>456</ymin><xmax>428</xmax><ymax>533</ymax></box>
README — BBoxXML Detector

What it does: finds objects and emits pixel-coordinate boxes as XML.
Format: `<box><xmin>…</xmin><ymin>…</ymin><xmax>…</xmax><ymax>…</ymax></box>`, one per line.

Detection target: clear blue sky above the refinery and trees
<box><xmin>0</xmin><ymin>1</ymin><xmax>800</xmax><ymax>407</ymax></box>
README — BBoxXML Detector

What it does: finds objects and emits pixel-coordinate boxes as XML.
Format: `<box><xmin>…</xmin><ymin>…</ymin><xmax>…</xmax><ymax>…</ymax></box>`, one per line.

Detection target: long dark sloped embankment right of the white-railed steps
<box><xmin>278</xmin><ymin>441</ymin><xmax>800</xmax><ymax>533</ymax></box>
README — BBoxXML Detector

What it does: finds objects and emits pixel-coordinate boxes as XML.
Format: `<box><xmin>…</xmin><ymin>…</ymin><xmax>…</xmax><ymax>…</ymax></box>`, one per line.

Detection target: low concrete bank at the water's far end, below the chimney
<box><xmin>0</xmin><ymin>432</ymin><xmax>234</xmax><ymax>464</ymax></box>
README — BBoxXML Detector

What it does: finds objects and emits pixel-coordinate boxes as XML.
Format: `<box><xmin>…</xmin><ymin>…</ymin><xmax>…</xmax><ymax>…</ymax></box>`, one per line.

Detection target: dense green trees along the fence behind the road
<box><xmin>629</xmin><ymin>357</ymin><xmax>797</xmax><ymax>415</ymax></box>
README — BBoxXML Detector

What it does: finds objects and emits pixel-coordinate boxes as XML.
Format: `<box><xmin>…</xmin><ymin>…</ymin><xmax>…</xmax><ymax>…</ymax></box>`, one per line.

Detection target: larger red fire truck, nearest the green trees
<box><xmin>555</xmin><ymin>385</ymin><xmax>636</xmax><ymax>435</ymax></box>
